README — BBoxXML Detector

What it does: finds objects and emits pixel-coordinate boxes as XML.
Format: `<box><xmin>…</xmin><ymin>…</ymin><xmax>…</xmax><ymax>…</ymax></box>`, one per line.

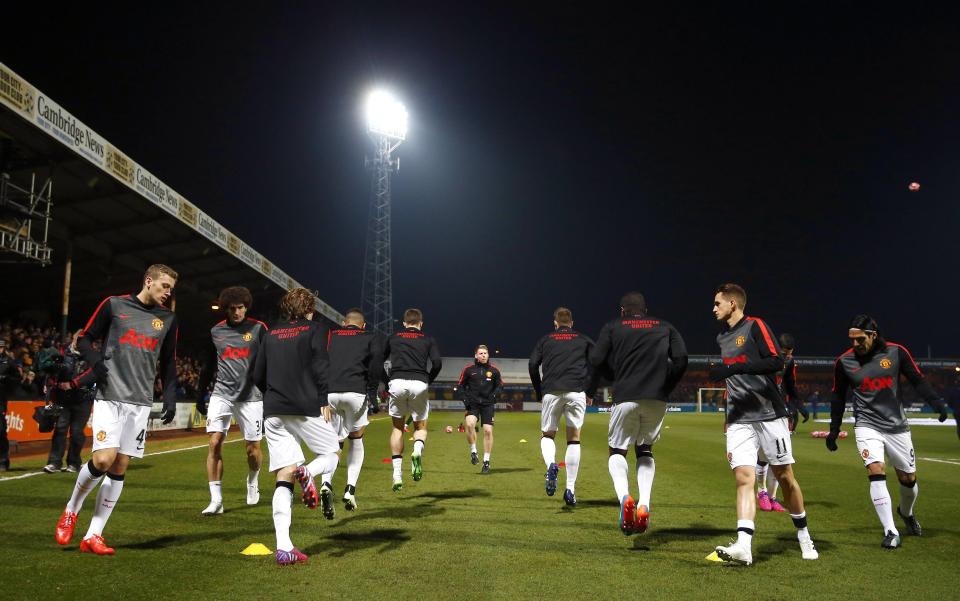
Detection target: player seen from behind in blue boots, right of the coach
<box><xmin>527</xmin><ymin>307</ymin><xmax>600</xmax><ymax>507</ymax></box>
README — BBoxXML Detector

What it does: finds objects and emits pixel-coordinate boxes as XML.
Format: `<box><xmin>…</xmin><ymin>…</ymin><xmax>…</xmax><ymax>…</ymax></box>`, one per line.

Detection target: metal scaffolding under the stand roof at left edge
<box><xmin>0</xmin><ymin>173</ymin><xmax>53</xmax><ymax>266</ymax></box>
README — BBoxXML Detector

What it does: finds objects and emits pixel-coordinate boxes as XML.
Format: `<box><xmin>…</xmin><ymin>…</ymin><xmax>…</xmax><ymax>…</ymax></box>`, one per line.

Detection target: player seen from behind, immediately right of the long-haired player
<box><xmin>322</xmin><ymin>308</ymin><xmax>383</xmax><ymax>510</ymax></box>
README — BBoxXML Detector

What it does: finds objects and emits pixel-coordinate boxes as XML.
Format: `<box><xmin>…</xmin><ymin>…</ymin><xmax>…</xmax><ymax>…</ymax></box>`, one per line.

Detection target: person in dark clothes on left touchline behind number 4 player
<box><xmin>43</xmin><ymin>330</ymin><xmax>94</xmax><ymax>474</ymax></box>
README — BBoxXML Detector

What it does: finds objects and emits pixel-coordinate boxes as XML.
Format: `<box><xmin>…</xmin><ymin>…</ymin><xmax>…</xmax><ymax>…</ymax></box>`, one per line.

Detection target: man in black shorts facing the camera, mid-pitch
<box><xmin>457</xmin><ymin>344</ymin><xmax>503</xmax><ymax>474</ymax></box>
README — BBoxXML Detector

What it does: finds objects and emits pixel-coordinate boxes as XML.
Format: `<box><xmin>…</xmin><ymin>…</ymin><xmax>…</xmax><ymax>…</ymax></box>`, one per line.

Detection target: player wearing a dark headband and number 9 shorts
<box><xmin>826</xmin><ymin>315</ymin><xmax>947</xmax><ymax>549</ymax></box>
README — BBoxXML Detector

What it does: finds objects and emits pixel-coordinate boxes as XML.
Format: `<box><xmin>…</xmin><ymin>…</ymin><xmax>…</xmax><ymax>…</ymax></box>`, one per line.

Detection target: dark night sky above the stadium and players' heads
<box><xmin>0</xmin><ymin>2</ymin><xmax>960</xmax><ymax>356</ymax></box>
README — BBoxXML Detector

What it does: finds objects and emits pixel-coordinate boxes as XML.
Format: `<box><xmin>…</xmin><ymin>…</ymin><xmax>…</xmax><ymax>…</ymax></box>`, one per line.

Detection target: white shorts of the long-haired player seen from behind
<box><xmin>264</xmin><ymin>415</ymin><xmax>340</xmax><ymax>472</ymax></box>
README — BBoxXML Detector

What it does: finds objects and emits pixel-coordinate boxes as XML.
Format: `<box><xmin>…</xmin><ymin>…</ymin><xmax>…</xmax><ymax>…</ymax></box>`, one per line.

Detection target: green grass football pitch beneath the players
<box><xmin>0</xmin><ymin>412</ymin><xmax>960</xmax><ymax>601</ymax></box>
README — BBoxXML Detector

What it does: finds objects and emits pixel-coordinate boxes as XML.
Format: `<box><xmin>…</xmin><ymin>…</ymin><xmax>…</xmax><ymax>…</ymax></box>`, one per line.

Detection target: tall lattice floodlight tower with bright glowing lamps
<box><xmin>360</xmin><ymin>91</ymin><xmax>407</xmax><ymax>335</ymax></box>
